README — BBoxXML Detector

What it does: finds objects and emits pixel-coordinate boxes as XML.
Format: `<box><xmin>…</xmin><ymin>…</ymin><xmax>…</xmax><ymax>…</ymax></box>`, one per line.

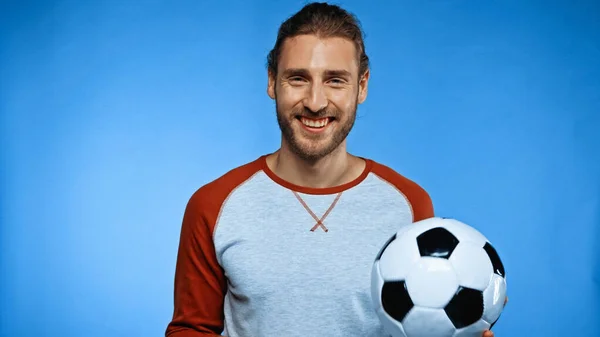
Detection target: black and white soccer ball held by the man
<box><xmin>371</xmin><ymin>217</ymin><xmax>506</xmax><ymax>337</ymax></box>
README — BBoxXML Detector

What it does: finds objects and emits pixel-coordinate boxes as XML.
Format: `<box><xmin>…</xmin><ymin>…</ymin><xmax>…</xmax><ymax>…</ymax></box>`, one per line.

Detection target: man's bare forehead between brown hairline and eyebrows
<box><xmin>279</xmin><ymin>35</ymin><xmax>358</xmax><ymax>74</ymax></box>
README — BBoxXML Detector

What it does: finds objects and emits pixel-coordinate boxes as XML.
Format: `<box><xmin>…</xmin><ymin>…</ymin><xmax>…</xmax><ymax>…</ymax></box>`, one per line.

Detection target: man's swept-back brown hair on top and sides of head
<box><xmin>267</xmin><ymin>2</ymin><xmax>369</xmax><ymax>79</ymax></box>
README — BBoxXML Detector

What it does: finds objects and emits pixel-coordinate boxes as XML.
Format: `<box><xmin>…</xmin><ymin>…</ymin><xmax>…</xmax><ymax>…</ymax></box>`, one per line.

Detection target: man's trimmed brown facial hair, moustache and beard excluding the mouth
<box><xmin>275</xmin><ymin>100</ymin><xmax>358</xmax><ymax>163</ymax></box>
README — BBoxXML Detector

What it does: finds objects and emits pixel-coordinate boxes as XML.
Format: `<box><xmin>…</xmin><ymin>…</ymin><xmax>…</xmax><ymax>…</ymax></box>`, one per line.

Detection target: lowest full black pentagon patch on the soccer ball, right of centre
<box><xmin>444</xmin><ymin>287</ymin><xmax>483</xmax><ymax>329</ymax></box>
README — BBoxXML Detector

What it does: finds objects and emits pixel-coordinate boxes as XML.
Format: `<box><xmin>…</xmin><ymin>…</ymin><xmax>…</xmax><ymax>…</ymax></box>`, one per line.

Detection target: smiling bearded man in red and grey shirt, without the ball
<box><xmin>166</xmin><ymin>3</ymin><xmax>502</xmax><ymax>337</ymax></box>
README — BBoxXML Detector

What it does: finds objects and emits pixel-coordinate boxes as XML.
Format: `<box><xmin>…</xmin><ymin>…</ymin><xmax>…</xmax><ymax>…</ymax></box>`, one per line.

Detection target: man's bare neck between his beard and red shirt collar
<box><xmin>267</xmin><ymin>142</ymin><xmax>365</xmax><ymax>188</ymax></box>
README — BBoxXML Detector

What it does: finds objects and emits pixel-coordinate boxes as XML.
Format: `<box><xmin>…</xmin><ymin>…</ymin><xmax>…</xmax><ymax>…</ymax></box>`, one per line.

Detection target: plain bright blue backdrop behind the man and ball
<box><xmin>0</xmin><ymin>0</ymin><xmax>600</xmax><ymax>337</ymax></box>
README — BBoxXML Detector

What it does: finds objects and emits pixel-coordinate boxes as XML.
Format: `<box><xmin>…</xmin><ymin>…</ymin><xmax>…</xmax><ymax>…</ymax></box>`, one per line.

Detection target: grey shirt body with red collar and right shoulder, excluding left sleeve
<box><xmin>206</xmin><ymin>159</ymin><xmax>432</xmax><ymax>337</ymax></box>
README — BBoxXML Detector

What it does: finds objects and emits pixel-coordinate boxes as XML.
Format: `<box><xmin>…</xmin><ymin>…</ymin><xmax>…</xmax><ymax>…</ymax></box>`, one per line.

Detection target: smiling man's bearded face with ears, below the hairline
<box><xmin>267</xmin><ymin>35</ymin><xmax>369</xmax><ymax>161</ymax></box>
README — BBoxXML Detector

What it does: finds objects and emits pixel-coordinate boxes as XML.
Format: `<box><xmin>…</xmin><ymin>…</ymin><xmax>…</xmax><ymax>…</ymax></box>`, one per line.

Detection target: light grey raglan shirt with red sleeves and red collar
<box><xmin>165</xmin><ymin>155</ymin><xmax>433</xmax><ymax>337</ymax></box>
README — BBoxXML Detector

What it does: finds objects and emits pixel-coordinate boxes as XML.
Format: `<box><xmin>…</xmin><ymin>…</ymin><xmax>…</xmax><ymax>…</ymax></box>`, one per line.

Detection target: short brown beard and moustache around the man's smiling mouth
<box><xmin>275</xmin><ymin>100</ymin><xmax>358</xmax><ymax>163</ymax></box>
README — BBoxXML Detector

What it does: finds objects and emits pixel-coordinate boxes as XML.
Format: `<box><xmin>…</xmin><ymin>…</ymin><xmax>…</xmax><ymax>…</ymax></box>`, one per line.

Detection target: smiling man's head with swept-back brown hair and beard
<box><xmin>267</xmin><ymin>3</ymin><xmax>369</xmax><ymax>161</ymax></box>
